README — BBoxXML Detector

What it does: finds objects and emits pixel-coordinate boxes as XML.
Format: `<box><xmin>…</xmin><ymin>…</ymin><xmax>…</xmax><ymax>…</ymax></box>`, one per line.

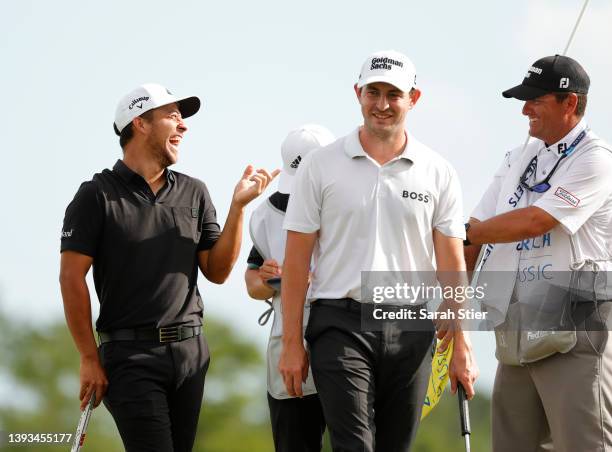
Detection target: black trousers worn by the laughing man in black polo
<box><xmin>100</xmin><ymin>335</ymin><xmax>209</xmax><ymax>452</ymax></box>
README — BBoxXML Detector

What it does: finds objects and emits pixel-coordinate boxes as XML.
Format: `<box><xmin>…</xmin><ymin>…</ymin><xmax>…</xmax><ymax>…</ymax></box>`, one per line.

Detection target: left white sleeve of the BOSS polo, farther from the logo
<box><xmin>283</xmin><ymin>151</ymin><xmax>322</xmax><ymax>233</ymax></box>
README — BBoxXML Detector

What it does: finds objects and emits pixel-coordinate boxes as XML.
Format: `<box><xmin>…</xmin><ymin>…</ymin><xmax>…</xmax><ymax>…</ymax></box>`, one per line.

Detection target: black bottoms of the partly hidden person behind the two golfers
<box><xmin>268</xmin><ymin>394</ymin><xmax>325</xmax><ymax>452</ymax></box>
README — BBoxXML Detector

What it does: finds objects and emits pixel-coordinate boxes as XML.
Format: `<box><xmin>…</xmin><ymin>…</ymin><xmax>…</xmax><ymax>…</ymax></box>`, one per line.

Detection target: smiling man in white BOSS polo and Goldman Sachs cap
<box><xmin>279</xmin><ymin>51</ymin><xmax>477</xmax><ymax>452</ymax></box>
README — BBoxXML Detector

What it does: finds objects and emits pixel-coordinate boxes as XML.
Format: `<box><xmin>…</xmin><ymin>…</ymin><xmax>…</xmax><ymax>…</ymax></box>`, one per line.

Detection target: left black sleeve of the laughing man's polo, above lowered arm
<box><xmin>60</xmin><ymin>181</ymin><xmax>104</xmax><ymax>257</ymax></box>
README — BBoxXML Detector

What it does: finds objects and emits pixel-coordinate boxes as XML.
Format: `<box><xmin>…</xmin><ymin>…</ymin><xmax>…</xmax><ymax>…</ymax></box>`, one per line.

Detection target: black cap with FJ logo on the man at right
<box><xmin>502</xmin><ymin>55</ymin><xmax>591</xmax><ymax>100</ymax></box>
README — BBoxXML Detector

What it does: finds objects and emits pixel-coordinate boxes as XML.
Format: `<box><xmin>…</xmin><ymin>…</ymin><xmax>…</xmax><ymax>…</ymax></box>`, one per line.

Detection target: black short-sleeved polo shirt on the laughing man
<box><xmin>61</xmin><ymin>160</ymin><xmax>220</xmax><ymax>331</ymax></box>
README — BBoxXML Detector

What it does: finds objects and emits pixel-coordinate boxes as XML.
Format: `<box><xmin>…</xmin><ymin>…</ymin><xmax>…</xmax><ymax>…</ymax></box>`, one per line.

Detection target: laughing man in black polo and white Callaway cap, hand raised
<box><xmin>60</xmin><ymin>84</ymin><xmax>278</xmax><ymax>451</ymax></box>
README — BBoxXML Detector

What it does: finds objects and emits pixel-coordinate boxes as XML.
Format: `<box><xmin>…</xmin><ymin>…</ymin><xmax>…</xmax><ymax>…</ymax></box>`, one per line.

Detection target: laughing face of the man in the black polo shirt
<box><xmin>144</xmin><ymin>103</ymin><xmax>187</xmax><ymax>168</ymax></box>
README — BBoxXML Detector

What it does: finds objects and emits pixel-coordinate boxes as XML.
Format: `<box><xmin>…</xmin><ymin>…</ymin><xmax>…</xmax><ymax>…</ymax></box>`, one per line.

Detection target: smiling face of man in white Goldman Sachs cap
<box><xmin>355</xmin><ymin>82</ymin><xmax>421</xmax><ymax>139</ymax></box>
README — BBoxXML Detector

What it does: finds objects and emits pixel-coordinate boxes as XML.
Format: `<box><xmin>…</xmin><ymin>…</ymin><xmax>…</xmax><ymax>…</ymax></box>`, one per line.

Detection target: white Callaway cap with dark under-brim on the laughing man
<box><xmin>113</xmin><ymin>83</ymin><xmax>200</xmax><ymax>135</ymax></box>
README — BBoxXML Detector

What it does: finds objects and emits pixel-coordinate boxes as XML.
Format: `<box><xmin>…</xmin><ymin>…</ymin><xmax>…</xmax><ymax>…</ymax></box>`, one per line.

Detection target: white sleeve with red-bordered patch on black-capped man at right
<box><xmin>533</xmin><ymin>147</ymin><xmax>612</xmax><ymax>234</ymax></box>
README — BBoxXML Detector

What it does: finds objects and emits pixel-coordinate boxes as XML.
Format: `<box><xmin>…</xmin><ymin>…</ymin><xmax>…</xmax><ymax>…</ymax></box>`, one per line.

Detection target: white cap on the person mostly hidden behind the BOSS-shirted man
<box><xmin>278</xmin><ymin>124</ymin><xmax>336</xmax><ymax>194</ymax></box>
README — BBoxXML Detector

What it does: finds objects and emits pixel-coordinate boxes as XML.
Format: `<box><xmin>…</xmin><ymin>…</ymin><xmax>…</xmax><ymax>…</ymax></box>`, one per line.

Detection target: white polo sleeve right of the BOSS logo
<box><xmin>433</xmin><ymin>165</ymin><xmax>465</xmax><ymax>239</ymax></box>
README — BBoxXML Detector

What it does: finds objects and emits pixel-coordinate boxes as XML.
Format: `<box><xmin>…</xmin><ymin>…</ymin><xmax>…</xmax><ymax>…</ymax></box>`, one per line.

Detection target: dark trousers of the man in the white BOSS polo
<box><xmin>306</xmin><ymin>299</ymin><xmax>434</xmax><ymax>452</ymax></box>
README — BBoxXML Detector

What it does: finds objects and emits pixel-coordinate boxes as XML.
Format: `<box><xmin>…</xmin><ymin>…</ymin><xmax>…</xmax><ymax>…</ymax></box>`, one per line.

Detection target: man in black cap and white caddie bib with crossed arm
<box><xmin>465</xmin><ymin>55</ymin><xmax>612</xmax><ymax>452</ymax></box>
